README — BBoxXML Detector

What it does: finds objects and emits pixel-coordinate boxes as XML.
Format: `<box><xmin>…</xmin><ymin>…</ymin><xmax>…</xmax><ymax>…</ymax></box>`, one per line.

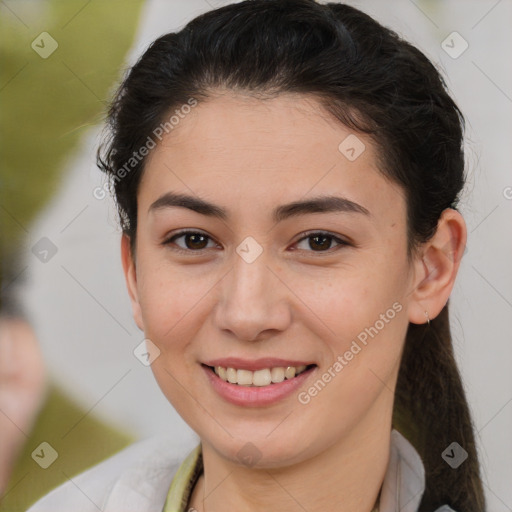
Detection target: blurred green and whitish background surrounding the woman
<box><xmin>0</xmin><ymin>0</ymin><xmax>512</xmax><ymax>512</ymax></box>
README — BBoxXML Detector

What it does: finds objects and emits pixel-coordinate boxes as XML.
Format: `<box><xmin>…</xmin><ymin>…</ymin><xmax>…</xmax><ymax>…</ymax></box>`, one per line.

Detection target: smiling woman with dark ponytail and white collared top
<box><xmin>30</xmin><ymin>0</ymin><xmax>485</xmax><ymax>512</ymax></box>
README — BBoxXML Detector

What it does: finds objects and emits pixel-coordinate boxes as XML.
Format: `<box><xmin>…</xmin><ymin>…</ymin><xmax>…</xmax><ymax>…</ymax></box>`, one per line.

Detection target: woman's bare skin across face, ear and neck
<box><xmin>121</xmin><ymin>92</ymin><xmax>466</xmax><ymax>512</ymax></box>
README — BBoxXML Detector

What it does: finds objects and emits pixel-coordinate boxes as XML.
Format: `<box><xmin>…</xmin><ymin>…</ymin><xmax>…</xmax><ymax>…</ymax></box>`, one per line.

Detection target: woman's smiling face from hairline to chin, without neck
<box><xmin>123</xmin><ymin>93</ymin><xmax>420</xmax><ymax>467</ymax></box>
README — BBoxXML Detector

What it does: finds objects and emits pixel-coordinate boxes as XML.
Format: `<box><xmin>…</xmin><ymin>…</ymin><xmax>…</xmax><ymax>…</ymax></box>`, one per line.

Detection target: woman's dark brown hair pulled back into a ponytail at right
<box><xmin>98</xmin><ymin>0</ymin><xmax>485</xmax><ymax>512</ymax></box>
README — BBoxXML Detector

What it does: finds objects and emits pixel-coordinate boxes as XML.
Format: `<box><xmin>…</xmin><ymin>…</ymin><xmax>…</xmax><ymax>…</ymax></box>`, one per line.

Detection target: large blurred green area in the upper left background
<box><xmin>0</xmin><ymin>0</ymin><xmax>143</xmax><ymax>284</ymax></box>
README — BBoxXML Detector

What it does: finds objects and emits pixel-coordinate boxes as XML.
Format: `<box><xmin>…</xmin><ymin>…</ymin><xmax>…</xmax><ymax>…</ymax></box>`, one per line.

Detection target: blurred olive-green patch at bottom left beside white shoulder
<box><xmin>0</xmin><ymin>384</ymin><xmax>135</xmax><ymax>512</ymax></box>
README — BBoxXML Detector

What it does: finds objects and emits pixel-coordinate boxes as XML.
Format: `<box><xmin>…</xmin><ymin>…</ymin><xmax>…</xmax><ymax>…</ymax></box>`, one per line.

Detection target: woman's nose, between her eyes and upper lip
<box><xmin>214</xmin><ymin>253</ymin><xmax>291</xmax><ymax>341</ymax></box>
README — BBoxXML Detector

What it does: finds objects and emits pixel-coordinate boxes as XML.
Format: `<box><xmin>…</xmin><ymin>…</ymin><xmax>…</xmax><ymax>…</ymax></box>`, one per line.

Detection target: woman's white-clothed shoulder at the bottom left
<box><xmin>27</xmin><ymin>436</ymin><xmax>185</xmax><ymax>512</ymax></box>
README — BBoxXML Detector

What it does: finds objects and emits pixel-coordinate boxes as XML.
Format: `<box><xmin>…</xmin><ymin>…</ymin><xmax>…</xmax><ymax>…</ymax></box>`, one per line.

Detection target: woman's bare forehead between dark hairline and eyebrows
<box><xmin>139</xmin><ymin>93</ymin><xmax>404</xmax><ymax>224</ymax></box>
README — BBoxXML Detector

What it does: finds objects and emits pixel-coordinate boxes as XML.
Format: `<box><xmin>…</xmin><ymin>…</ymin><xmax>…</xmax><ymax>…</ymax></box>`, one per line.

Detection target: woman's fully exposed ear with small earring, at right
<box><xmin>408</xmin><ymin>208</ymin><xmax>467</xmax><ymax>324</ymax></box>
